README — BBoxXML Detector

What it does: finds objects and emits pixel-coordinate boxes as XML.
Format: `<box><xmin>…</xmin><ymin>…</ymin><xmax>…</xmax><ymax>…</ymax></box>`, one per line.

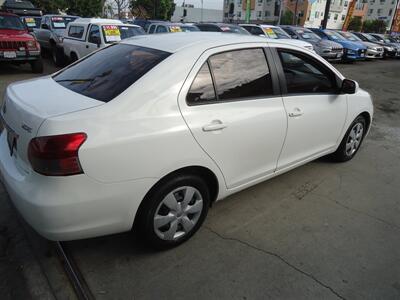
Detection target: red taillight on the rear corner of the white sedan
<box><xmin>28</xmin><ymin>133</ymin><xmax>87</xmax><ymax>176</ymax></box>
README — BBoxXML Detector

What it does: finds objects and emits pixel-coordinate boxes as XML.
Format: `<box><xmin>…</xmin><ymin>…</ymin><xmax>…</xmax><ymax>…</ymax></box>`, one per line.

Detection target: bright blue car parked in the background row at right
<box><xmin>310</xmin><ymin>28</ymin><xmax>367</xmax><ymax>61</ymax></box>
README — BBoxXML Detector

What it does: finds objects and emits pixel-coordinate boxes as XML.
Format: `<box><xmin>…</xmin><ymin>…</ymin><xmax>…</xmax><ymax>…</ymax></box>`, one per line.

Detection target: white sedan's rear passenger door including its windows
<box><xmin>179</xmin><ymin>46</ymin><xmax>287</xmax><ymax>188</ymax></box>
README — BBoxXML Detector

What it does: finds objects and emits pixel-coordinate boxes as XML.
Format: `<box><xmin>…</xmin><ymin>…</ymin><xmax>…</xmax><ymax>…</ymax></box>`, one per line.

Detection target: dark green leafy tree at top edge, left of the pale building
<box><xmin>130</xmin><ymin>0</ymin><xmax>175</xmax><ymax>20</ymax></box>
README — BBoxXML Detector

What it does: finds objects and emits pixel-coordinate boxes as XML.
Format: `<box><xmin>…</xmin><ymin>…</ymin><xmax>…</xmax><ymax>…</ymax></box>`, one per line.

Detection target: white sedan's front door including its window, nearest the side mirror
<box><xmin>275</xmin><ymin>49</ymin><xmax>347</xmax><ymax>169</ymax></box>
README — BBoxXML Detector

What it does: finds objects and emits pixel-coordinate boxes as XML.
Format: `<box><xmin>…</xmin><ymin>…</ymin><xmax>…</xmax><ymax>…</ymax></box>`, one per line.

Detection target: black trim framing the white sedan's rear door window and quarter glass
<box><xmin>185</xmin><ymin>47</ymin><xmax>281</xmax><ymax>106</ymax></box>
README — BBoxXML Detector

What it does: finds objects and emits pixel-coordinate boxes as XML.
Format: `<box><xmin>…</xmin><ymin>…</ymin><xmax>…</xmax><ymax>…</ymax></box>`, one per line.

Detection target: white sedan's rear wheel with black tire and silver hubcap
<box><xmin>134</xmin><ymin>175</ymin><xmax>210</xmax><ymax>249</ymax></box>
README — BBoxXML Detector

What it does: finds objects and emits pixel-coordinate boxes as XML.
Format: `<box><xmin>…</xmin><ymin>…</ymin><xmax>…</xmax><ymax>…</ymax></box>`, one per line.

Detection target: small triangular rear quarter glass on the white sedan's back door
<box><xmin>186</xmin><ymin>62</ymin><xmax>216</xmax><ymax>105</ymax></box>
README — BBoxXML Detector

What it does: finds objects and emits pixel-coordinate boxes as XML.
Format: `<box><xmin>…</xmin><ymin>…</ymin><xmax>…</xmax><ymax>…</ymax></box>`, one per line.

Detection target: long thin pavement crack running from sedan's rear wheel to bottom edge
<box><xmin>203</xmin><ymin>226</ymin><xmax>346</xmax><ymax>300</ymax></box>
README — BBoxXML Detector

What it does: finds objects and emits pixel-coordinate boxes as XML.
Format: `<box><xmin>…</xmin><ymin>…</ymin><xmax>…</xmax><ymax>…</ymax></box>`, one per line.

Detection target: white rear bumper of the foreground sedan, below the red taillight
<box><xmin>0</xmin><ymin>134</ymin><xmax>156</xmax><ymax>241</ymax></box>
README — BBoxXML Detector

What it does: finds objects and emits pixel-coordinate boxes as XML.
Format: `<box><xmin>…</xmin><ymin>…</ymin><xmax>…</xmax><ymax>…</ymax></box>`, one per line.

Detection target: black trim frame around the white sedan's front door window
<box><xmin>271</xmin><ymin>47</ymin><xmax>342</xmax><ymax>97</ymax></box>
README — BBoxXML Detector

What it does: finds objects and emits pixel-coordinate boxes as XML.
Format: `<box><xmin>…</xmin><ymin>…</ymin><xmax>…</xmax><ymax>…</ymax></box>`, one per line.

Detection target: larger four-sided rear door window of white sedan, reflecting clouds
<box><xmin>209</xmin><ymin>49</ymin><xmax>273</xmax><ymax>100</ymax></box>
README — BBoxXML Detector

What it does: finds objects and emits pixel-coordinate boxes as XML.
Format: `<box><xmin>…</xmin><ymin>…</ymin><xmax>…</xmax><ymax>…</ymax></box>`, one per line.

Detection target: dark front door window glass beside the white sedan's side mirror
<box><xmin>278</xmin><ymin>50</ymin><xmax>337</xmax><ymax>94</ymax></box>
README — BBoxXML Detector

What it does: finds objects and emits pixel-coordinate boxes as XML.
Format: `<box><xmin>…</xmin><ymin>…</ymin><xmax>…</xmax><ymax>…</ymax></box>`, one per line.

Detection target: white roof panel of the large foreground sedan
<box><xmin>121</xmin><ymin>32</ymin><xmax>266</xmax><ymax>53</ymax></box>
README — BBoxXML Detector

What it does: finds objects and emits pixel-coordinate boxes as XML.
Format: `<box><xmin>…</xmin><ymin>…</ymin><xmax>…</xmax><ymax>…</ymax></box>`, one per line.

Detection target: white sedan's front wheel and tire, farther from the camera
<box><xmin>331</xmin><ymin>116</ymin><xmax>367</xmax><ymax>162</ymax></box>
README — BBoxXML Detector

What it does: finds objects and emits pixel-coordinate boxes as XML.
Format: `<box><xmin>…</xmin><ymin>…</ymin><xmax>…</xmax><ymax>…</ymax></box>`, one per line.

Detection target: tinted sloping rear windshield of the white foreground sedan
<box><xmin>53</xmin><ymin>44</ymin><xmax>171</xmax><ymax>102</ymax></box>
